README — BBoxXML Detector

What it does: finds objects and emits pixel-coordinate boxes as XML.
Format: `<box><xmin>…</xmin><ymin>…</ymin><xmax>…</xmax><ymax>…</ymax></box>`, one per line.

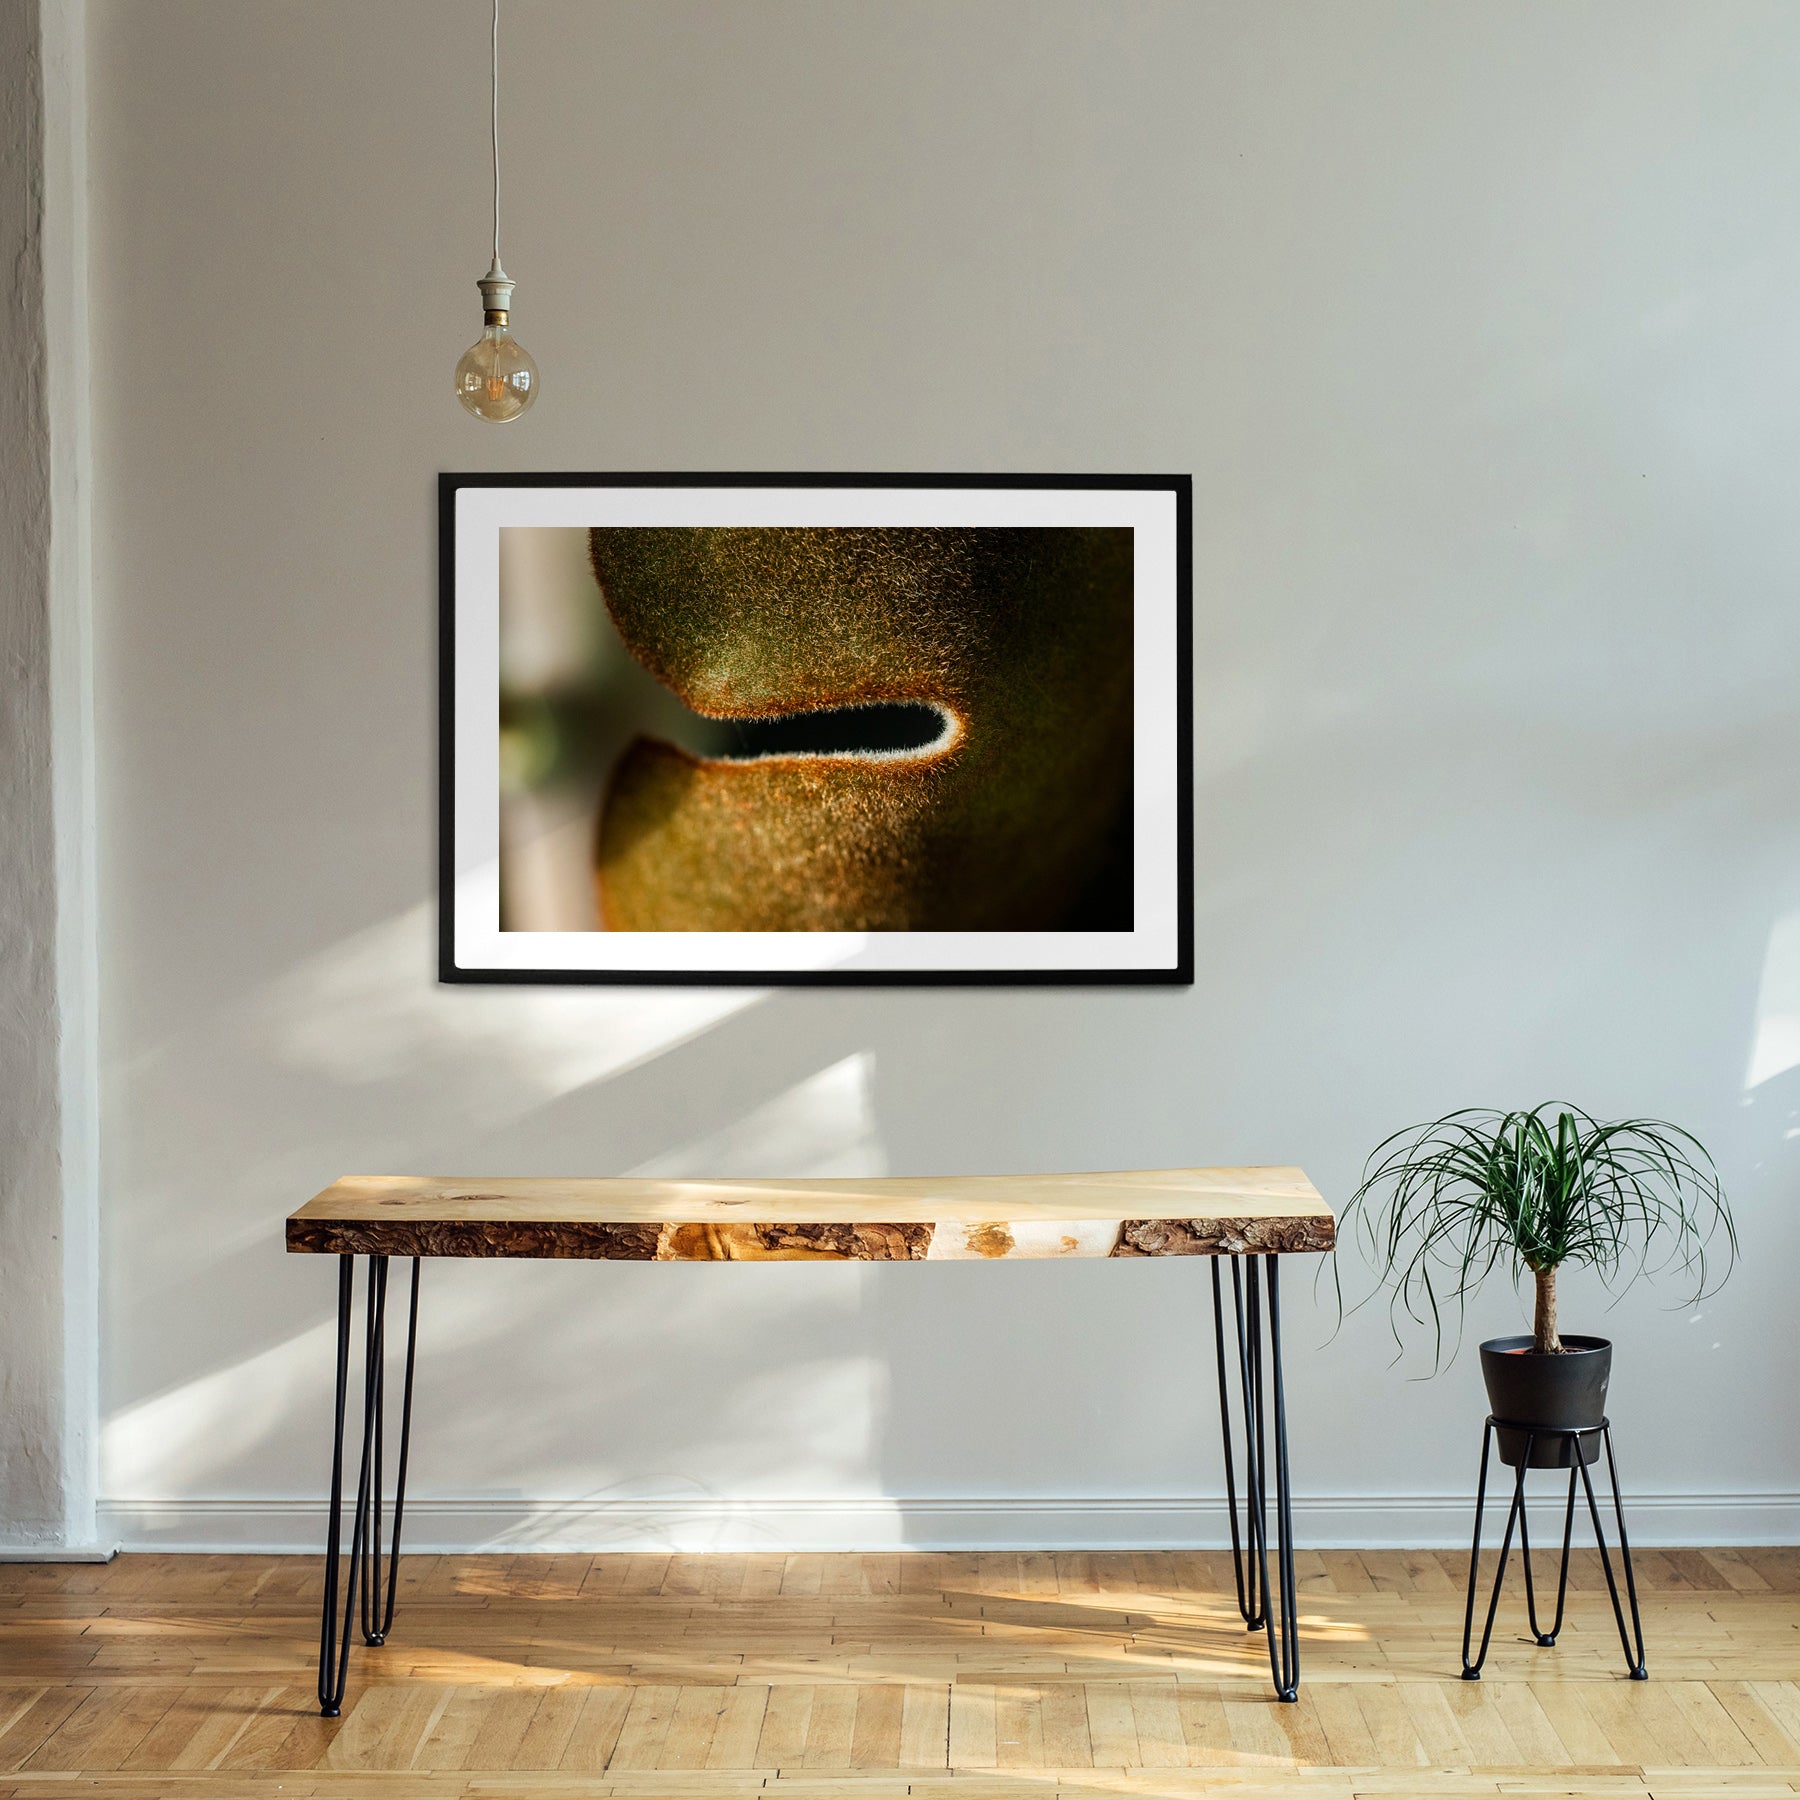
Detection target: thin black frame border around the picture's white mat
<box><xmin>437</xmin><ymin>470</ymin><xmax>1193</xmax><ymax>988</ymax></box>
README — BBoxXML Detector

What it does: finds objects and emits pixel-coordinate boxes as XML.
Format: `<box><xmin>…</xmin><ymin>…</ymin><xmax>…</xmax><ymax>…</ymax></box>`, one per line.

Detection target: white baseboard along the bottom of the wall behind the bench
<box><xmin>101</xmin><ymin>1494</ymin><xmax>1800</xmax><ymax>1553</ymax></box>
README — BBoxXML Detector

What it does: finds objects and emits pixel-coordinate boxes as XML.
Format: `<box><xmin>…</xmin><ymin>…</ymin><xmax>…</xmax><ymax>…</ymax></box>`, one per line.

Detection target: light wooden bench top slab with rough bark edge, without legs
<box><xmin>288</xmin><ymin>1168</ymin><xmax>1336</xmax><ymax>1262</ymax></box>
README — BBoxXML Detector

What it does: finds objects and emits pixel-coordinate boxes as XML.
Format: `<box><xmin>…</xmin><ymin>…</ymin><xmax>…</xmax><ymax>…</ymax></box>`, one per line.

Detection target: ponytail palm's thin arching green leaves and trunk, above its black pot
<box><xmin>1345</xmin><ymin>1102</ymin><xmax>1737</xmax><ymax>1364</ymax></box>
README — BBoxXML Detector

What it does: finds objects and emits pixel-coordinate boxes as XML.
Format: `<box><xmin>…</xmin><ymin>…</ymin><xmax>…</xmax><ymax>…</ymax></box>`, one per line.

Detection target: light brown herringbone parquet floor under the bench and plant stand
<box><xmin>0</xmin><ymin>1550</ymin><xmax>1800</xmax><ymax>1800</ymax></box>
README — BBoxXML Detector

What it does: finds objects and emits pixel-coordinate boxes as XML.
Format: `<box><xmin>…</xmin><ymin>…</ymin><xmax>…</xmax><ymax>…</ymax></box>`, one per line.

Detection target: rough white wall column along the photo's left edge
<box><xmin>0</xmin><ymin>0</ymin><xmax>97</xmax><ymax>1552</ymax></box>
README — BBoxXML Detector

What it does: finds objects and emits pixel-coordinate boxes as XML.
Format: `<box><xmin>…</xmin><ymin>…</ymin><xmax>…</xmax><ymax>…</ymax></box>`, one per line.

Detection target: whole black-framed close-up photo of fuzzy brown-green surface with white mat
<box><xmin>439</xmin><ymin>473</ymin><xmax>1193</xmax><ymax>985</ymax></box>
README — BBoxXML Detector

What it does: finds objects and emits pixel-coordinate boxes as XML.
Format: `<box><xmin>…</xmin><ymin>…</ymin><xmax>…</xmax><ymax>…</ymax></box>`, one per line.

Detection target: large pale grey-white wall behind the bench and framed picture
<box><xmin>90</xmin><ymin>0</ymin><xmax>1800</xmax><ymax>1546</ymax></box>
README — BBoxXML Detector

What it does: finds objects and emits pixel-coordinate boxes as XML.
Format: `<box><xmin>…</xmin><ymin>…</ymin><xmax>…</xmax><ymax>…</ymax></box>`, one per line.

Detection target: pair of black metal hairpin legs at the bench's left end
<box><xmin>319</xmin><ymin>1256</ymin><xmax>419</xmax><ymax>1719</ymax></box>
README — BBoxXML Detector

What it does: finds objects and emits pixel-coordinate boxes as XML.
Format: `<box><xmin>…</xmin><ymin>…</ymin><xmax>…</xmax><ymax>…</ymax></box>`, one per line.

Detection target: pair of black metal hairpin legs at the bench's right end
<box><xmin>1213</xmin><ymin>1256</ymin><xmax>1300</xmax><ymax>1701</ymax></box>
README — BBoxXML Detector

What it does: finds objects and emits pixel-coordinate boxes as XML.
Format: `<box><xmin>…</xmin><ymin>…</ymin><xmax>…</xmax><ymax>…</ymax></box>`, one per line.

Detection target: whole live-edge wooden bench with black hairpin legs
<box><xmin>288</xmin><ymin>1168</ymin><xmax>1336</xmax><ymax>1717</ymax></box>
